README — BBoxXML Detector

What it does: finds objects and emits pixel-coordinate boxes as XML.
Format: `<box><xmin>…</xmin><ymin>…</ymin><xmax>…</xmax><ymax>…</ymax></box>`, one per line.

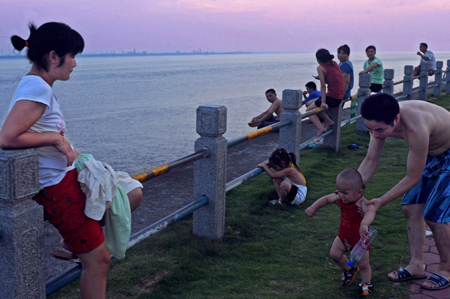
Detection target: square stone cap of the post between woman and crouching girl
<box><xmin>197</xmin><ymin>105</ymin><xmax>227</xmax><ymax>137</ymax></box>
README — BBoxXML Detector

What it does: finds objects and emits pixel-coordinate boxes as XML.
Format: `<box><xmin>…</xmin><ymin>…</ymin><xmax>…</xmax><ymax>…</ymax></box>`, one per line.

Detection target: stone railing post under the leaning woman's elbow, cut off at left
<box><xmin>0</xmin><ymin>149</ymin><xmax>45</xmax><ymax>299</ymax></box>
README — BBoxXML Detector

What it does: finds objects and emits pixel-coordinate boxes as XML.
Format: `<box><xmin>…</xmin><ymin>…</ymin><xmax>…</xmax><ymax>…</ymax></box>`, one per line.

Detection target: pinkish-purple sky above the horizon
<box><xmin>0</xmin><ymin>0</ymin><xmax>450</xmax><ymax>54</ymax></box>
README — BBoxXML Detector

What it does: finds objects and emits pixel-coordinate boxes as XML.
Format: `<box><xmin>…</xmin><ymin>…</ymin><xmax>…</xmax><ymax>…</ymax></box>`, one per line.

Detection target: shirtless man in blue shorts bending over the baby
<box><xmin>358</xmin><ymin>93</ymin><xmax>450</xmax><ymax>290</ymax></box>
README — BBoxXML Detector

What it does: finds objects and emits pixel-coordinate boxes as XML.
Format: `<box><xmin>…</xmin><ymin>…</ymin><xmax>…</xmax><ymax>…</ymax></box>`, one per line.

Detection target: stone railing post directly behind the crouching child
<box><xmin>279</xmin><ymin>89</ymin><xmax>302</xmax><ymax>163</ymax></box>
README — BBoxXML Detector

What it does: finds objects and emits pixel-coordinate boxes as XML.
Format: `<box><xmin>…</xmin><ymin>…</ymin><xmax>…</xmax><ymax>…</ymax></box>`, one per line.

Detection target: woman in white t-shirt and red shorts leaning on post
<box><xmin>0</xmin><ymin>22</ymin><xmax>142</xmax><ymax>298</ymax></box>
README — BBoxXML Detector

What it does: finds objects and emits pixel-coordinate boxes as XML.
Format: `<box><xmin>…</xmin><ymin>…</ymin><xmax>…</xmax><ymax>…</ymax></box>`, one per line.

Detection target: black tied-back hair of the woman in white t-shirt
<box><xmin>11</xmin><ymin>22</ymin><xmax>84</xmax><ymax>71</ymax></box>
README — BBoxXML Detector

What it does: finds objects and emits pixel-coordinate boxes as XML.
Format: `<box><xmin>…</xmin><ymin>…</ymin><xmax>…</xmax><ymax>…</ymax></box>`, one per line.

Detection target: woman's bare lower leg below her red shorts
<box><xmin>78</xmin><ymin>243</ymin><xmax>111</xmax><ymax>299</ymax></box>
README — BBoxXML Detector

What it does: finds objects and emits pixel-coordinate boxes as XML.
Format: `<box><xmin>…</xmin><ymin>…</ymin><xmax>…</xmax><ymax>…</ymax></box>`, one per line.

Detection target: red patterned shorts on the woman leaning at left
<box><xmin>33</xmin><ymin>169</ymin><xmax>105</xmax><ymax>254</ymax></box>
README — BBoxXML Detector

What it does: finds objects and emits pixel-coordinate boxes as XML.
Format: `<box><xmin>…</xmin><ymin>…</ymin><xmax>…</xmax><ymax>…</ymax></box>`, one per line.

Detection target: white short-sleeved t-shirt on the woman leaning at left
<box><xmin>9</xmin><ymin>76</ymin><xmax>75</xmax><ymax>189</ymax></box>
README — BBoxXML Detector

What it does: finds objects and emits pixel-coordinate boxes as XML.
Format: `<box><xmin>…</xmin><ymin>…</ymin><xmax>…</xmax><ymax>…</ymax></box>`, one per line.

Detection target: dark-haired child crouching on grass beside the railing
<box><xmin>258</xmin><ymin>148</ymin><xmax>307</xmax><ymax>205</ymax></box>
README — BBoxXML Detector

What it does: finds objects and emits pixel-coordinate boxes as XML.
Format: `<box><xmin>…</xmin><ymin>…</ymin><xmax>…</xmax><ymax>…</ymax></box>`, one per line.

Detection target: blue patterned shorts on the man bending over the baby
<box><xmin>402</xmin><ymin>150</ymin><xmax>450</xmax><ymax>223</ymax></box>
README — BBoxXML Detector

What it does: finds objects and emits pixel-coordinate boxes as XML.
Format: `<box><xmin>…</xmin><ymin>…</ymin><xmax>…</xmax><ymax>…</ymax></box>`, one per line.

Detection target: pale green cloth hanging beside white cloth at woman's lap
<box><xmin>75</xmin><ymin>154</ymin><xmax>131</xmax><ymax>259</ymax></box>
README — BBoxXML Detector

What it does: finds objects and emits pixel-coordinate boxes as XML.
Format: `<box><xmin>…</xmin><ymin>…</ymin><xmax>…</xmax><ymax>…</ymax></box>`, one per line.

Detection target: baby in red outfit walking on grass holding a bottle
<box><xmin>305</xmin><ymin>168</ymin><xmax>375</xmax><ymax>296</ymax></box>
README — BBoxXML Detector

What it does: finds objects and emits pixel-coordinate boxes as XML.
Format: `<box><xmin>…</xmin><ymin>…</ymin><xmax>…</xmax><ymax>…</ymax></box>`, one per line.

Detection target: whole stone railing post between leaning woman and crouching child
<box><xmin>193</xmin><ymin>105</ymin><xmax>227</xmax><ymax>240</ymax></box>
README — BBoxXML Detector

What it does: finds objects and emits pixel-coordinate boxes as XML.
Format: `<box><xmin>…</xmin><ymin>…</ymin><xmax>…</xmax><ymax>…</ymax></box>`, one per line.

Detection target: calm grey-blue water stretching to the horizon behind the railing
<box><xmin>0</xmin><ymin>52</ymin><xmax>450</xmax><ymax>173</ymax></box>
